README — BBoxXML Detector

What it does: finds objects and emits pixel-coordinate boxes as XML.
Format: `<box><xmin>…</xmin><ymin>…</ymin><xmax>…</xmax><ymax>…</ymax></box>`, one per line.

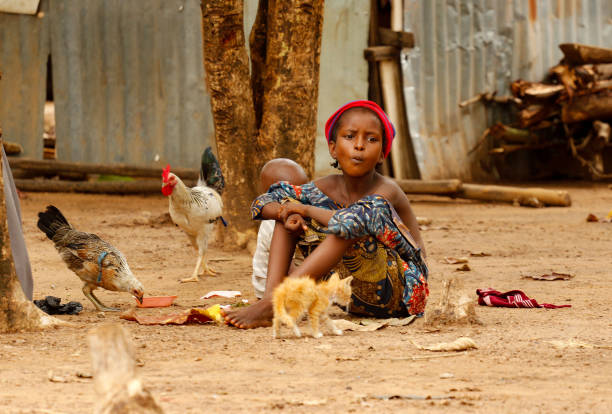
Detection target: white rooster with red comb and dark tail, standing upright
<box><xmin>162</xmin><ymin>147</ymin><xmax>226</xmax><ymax>282</ymax></box>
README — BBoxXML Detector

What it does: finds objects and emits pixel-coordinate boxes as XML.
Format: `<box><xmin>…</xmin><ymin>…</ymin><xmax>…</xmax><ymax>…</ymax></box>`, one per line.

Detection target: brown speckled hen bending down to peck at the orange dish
<box><xmin>38</xmin><ymin>206</ymin><xmax>144</xmax><ymax>311</ymax></box>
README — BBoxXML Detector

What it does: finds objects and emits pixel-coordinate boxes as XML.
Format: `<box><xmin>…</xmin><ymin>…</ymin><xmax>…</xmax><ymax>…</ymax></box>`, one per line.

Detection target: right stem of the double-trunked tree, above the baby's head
<box><xmin>259</xmin><ymin>0</ymin><xmax>323</xmax><ymax>176</ymax></box>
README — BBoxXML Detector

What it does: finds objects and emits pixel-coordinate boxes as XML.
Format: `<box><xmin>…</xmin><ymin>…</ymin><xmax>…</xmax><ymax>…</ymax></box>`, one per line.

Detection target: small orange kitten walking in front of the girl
<box><xmin>272</xmin><ymin>273</ymin><xmax>353</xmax><ymax>338</ymax></box>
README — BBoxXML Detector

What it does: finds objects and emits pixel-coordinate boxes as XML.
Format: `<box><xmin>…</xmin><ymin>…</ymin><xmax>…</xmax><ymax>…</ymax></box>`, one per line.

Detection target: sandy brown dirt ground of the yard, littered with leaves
<box><xmin>0</xmin><ymin>183</ymin><xmax>612</xmax><ymax>413</ymax></box>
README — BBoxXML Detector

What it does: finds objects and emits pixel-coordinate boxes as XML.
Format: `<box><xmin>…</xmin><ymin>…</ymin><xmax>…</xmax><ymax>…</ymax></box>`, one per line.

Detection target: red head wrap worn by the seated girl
<box><xmin>325</xmin><ymin>100</ymin><xmax>395</xmax><ymax>163</ymax></box>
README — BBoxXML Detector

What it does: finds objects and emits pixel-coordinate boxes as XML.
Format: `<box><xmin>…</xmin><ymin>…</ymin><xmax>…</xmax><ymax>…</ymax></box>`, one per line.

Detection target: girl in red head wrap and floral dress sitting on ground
<box><xmin>224</xmin><ymin>100</ymin><xmax>429</xmax><ymax>328</ymax></box>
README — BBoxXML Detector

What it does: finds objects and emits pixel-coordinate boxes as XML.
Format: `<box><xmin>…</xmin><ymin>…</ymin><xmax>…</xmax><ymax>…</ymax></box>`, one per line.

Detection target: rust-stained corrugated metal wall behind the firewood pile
<box><xmin>402</xmin><ymin>0</ymin><xmax>612</xmax><ymax>179</ymax></box>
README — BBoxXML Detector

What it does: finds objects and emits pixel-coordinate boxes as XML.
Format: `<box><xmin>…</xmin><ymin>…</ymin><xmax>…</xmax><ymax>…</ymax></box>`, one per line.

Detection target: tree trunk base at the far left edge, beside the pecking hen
<box><xmin>0</xmin><ymin>140</ymin><xmax>65</xmax><ymax>333</ymax></box>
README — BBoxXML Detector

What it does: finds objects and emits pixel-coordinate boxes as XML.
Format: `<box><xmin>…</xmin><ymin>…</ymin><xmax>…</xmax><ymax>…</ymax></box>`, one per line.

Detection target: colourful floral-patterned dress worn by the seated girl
<box><xmin>251</xmin><ymin>182</ymin><xmax>429</xmax><ymax>318</ymax></box>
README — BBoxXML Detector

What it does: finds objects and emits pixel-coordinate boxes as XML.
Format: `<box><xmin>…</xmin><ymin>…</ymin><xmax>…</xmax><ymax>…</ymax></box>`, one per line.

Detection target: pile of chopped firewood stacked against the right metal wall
<box><xmin>479</xmin><ymin>43</ymin><xmax>612</xmax><ymax>179</ymax></box>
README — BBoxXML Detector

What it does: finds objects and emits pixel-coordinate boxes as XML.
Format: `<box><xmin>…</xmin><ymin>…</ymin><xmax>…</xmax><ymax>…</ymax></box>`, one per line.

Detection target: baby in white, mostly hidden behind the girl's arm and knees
<box><xmin>252</xmin><ymin>158</ymin><xmax>308</xmax><ymax>299</ymax></box>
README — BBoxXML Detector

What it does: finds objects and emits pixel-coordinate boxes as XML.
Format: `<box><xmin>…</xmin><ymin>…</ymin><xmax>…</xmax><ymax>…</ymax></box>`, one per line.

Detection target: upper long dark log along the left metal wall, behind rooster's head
<box><xmin>9</xmin><ymin>157</ymin><xmax>200</xmax><ymax>180</ymax></box>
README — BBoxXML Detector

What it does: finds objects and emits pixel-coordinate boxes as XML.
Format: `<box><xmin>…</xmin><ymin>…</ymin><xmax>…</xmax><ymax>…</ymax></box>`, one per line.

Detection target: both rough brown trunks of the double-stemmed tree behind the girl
<box><xmin>202</xmin><ymin>0</ymin><xmax>323</xmax><ymax>246</ymax></box>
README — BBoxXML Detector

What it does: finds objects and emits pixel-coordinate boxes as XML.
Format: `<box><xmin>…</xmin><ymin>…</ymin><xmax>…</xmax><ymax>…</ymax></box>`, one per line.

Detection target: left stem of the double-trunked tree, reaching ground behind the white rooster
<box><xmin>202</xmin><ymin>0</ymin><xmax>261</xmax><ymax>245</ymax></box>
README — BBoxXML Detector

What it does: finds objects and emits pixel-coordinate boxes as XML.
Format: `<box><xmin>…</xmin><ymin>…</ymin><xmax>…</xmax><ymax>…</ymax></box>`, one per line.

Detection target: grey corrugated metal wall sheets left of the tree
<box><xmin>0</xmin><ymin>0</ymin><xmax>214</xmax><ymax>167</ymax></box>
